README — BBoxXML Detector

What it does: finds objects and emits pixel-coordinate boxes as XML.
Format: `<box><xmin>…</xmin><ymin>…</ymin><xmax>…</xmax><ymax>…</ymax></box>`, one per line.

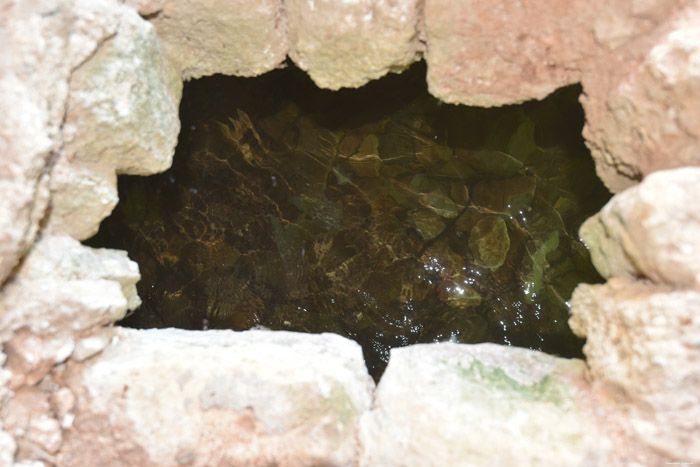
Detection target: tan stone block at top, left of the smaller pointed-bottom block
<box><xmin>151</xmin><ymin>0</ymin><xmax>288</xmax><ymax>80</ymax></box>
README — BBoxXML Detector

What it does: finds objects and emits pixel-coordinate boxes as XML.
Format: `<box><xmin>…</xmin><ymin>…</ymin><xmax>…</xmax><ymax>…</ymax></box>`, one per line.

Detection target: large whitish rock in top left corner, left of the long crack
<box><xmin>0</xmin><ymin>0</ymin><xmax>123</xmax><ymax>283</ymax></box>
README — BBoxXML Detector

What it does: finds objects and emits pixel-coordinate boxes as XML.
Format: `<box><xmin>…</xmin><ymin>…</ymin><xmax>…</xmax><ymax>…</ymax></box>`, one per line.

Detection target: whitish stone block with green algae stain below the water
<box><xmin>360</xmin><ymin>343</ymin><xmax>610</xmax><ymax>466</ymax></box>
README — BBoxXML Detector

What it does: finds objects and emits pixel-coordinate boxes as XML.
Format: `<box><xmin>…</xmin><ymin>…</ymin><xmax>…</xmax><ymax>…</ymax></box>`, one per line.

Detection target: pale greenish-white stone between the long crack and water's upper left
<box><xmin>49</xmin><ymin>7</ymin><xmax>182</xmax><ymax>240</ymax></box>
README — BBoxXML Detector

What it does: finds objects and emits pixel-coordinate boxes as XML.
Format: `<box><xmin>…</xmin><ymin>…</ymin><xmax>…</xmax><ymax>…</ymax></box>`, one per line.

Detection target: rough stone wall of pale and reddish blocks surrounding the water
<box><xmin>0</xmin><ymin>0</ymin><xmax>700</xmax><ymax>466</ymax></box>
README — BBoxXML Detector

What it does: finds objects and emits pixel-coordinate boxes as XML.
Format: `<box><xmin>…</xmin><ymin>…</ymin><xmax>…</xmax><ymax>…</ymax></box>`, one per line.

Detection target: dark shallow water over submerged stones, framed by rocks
<box><xmin>88</xmin><ymin>64</ymin><xmax>610</xmax><ymax>377</ymax></box>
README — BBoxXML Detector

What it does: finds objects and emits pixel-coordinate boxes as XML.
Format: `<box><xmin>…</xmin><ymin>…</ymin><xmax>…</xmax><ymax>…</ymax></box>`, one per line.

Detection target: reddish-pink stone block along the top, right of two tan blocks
<box><xmin>425</xmin><ymin>0</ymin><xmax>596</xmax><ymax>106</ymax></box>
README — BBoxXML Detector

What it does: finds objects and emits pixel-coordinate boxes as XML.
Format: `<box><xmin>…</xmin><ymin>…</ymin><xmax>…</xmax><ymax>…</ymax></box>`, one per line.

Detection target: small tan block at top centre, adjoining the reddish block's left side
<box><xmin>285</xmin><ymin>0</ymin><xmax>421</xmax><ymax>89</ymax></box>
